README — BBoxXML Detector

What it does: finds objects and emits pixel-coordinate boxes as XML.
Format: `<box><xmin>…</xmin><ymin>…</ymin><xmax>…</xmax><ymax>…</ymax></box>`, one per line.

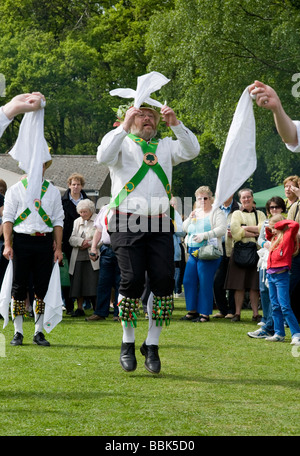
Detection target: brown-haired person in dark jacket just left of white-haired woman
<box><xmin>62</xmin><ymin>173</ymin><xmax>87</xmax><ymax>314</ymax></box>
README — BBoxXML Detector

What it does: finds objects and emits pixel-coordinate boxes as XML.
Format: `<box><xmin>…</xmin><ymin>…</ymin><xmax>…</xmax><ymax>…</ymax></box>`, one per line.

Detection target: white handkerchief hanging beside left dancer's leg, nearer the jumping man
<box><xmin>44</xmin><ymin>261</ymin><xmax>63</xmax><ymax>333</ymax></box>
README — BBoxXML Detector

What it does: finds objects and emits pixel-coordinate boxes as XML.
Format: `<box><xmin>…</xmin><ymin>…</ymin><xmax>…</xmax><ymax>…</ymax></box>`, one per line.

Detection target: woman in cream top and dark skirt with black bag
<box><xmin>225</xmin><ymin>188</ymin><xmax>266</xmax><ymax>322</ymax></box>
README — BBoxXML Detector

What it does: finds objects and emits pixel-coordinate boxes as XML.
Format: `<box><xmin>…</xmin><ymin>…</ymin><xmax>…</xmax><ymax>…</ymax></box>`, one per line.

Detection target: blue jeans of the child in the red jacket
<box><xmin>268</xmin><ymin>271</ymin><xmax>300</xmax><ymax>336</ymax></box>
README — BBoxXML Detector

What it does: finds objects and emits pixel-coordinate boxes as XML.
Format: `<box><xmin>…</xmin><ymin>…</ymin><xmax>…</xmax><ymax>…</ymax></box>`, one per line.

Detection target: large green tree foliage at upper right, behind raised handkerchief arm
<box><xmin>147</xmin><ymin>0</ymin><xmax>300</xmax><ymax>194</ymax></box>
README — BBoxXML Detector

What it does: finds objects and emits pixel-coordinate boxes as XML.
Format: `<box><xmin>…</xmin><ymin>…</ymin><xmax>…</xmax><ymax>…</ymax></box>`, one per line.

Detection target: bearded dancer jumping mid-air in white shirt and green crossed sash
<box><xmin>97</xmin><ymin>73</ymin><xmax>200</xmax><ymax>374</ymax></box>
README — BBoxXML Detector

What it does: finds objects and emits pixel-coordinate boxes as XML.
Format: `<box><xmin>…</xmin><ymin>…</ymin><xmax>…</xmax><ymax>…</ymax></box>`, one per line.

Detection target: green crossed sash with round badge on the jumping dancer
<box><xmin>108</xmin><ymin>133</ymin><xmax>174</xmax><ymax>220</ymax></box>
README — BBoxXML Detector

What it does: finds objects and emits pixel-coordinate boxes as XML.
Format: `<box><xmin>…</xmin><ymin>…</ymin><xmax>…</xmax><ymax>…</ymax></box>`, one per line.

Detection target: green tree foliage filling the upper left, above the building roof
<box><xmin>0</xmin><ymin>0</ymin><xmax>170</xmax><ymax>154</ymax></box>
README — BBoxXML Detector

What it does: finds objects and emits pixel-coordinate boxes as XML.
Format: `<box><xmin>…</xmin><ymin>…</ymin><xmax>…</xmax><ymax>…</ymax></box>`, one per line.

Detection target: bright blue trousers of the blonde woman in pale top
<box><xmin>183</xmin><ymin>248</ymin><xmax>221</xmax><ymax>315</ymax></box>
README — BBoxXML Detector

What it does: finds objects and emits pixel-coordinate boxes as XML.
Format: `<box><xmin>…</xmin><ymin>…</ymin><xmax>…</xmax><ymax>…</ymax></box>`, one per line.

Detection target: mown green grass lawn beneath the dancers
<box><xmin>0</xmin><ymin>299</ymin><xmax>300</xmax><ymax>436</ymax></box>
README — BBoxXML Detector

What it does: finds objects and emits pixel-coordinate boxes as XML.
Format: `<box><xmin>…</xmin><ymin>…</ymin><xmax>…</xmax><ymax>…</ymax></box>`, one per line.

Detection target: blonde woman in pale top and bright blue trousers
<box><xmin>182</xmin><ymin>186</ymin><xmax>227</xmax><ymax>322</ymax></box>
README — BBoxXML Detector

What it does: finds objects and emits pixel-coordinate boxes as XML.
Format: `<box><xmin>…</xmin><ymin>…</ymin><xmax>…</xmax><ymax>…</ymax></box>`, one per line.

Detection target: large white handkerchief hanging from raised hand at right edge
<box><xmin>213</xmin><ymin>87</ymin><xmax>256</xmax><ymax>210</ymax></box>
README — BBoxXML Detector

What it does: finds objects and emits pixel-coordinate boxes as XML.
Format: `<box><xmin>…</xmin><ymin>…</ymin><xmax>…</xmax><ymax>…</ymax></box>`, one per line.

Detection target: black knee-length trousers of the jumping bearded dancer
<box><xmin>109</xmin><ymin>214</ymin><xmax>174</xmax><ymax>298</ymax></box>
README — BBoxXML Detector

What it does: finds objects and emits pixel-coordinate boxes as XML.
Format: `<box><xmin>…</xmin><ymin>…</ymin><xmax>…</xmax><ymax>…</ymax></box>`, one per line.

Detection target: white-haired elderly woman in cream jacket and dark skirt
<box><xmin>69</xmin><ymin>199</ymin><xmax>99</xmax><ymax>317</ymax></box>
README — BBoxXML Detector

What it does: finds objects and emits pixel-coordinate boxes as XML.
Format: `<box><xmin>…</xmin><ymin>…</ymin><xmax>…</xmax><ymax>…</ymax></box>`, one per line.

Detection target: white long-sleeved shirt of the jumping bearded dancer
<box><xmin>97</xmin><ymin>123</ymin><xmax>200</xmax><ymax>216</ymax></box>
